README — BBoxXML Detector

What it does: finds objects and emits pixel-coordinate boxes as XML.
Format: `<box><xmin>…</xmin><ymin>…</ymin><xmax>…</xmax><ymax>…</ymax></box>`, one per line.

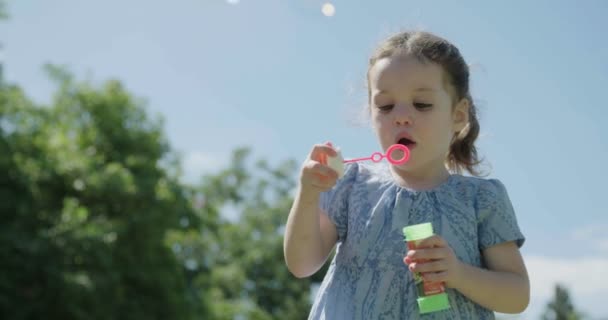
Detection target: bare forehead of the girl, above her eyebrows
<box><xmin>369</xmin><ymin>54</ymin><xmax>444</xmax><ymax>93</ymax></box>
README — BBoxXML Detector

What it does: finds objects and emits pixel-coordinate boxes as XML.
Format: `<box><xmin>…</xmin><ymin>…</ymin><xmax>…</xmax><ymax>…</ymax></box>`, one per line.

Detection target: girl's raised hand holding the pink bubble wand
<box><xmin>300</xmin><ymin>142</ymin><xmax>338</xmax><ymax>192</ymax></box>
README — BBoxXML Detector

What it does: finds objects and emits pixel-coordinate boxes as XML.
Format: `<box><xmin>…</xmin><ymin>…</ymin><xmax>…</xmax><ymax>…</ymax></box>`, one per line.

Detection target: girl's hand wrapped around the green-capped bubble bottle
<box><xmin>403</xmin><ymin>235</ymin><xmax>463</xmax><ymax>288</ymax></box>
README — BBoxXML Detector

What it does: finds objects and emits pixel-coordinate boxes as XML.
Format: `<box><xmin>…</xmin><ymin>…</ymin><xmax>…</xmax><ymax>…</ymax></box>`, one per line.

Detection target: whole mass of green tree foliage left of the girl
<box><xmin>0</xmin><ymin>65</ymin><xmax>326</xmax><ymax>320</ymax></box>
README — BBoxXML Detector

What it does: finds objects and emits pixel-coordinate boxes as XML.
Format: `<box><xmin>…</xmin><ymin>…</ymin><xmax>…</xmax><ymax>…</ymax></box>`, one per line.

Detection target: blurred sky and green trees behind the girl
<box><xmin>0</xmin><ymin>0</ymin><xmax>608</xmax><ymax>320</ymax></box>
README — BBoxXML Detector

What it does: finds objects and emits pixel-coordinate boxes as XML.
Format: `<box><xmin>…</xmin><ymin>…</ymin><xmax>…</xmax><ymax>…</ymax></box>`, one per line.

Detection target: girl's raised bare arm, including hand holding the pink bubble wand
<box><xmin>283</xmin><ymin>145</ymin><xmax>338</xmax><ymax>278</ymax></box>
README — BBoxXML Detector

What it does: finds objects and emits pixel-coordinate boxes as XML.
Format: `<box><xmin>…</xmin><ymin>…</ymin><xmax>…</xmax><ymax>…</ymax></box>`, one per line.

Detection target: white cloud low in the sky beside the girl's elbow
<box><xmin>522</xmin><ymin>252</ymin><xmax>608</xmax><ymax>319</ymax></box>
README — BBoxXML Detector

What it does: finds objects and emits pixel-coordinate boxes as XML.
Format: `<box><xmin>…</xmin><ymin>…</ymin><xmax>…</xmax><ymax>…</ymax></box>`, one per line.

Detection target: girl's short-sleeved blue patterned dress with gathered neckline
<box><xmin>309</xmin><ymin>163</ymin><xmax>525</xmax><ymax>320</ymax></box>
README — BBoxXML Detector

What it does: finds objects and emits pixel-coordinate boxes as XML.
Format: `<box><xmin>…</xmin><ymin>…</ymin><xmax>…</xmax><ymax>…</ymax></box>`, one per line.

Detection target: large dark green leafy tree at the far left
<box><xmin>0</xmin><ymin>66</ymin><xmax>204</xmax><ymax>319</ymax></box>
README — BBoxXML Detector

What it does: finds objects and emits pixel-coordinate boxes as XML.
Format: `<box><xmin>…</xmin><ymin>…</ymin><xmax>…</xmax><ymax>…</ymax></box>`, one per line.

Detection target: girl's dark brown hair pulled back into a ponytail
<box><xmin>367</xmin><ymin>31</ymin><xmax>481</xmax><ymax>176</ymax></box>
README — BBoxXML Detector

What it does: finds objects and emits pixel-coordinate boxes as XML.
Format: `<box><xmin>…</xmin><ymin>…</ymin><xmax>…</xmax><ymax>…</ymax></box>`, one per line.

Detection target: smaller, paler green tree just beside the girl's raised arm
<box><xmin>167</xmin><ymin>148</ymin><xmax>327</xmax><ymax>320</ymax></box>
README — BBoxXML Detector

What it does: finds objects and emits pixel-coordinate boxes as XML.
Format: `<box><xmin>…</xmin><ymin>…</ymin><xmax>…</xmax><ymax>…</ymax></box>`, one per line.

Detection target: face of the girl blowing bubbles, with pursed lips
<box><xmin>368</xmin><ymin>54</ymin><xmax>468</xmax><ymax>176</ymax></box>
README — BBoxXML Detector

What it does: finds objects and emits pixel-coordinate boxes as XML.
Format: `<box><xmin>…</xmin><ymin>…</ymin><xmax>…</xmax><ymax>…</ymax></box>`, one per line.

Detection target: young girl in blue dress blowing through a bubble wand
<box><xmin>284</xmin><ymin>32</ymin><xmax>530</xmax><ymax>319</ymax></box>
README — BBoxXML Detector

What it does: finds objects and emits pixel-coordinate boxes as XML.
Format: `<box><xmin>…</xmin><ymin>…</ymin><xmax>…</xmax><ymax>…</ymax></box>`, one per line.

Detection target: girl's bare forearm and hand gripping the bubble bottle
<box><xmin>405</xmin><ymin>236</ymin><xmax>530</xmax><ymax>313</ymax></box>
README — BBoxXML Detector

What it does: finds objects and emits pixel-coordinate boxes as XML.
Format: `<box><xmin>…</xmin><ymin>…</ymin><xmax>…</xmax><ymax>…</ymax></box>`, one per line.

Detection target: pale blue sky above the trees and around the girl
<box><xmin>0</xmin><ymin>0</ymin><xmax>608</xmax><ymax>319</ymax></box>
